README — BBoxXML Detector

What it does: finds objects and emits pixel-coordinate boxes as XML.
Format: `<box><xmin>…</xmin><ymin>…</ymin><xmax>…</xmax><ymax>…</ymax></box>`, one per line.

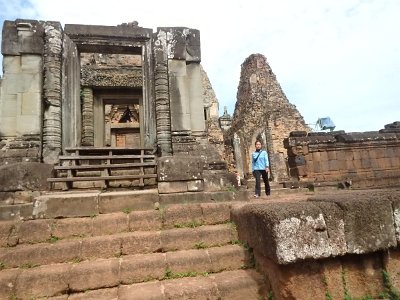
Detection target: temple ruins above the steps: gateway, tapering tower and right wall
<box><xmin>0</xmin><ymin>19</ymin><xmax>399</xmax><ymax>197</ymax></box>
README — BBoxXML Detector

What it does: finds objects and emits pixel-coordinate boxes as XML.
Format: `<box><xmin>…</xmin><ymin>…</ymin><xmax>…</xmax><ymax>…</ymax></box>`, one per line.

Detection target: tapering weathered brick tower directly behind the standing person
<box><xmin>227</xmin><ymin>54</ymin><xmax>309</xmax><ymax>180</ymax></box>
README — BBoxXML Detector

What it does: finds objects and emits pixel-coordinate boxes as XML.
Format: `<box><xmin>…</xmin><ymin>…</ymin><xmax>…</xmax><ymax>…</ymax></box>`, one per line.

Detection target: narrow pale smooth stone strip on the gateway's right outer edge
<box><xmin>186</xmin><ymin>63</ymin><xmax>206</xmax><ymax>136</ymax></box>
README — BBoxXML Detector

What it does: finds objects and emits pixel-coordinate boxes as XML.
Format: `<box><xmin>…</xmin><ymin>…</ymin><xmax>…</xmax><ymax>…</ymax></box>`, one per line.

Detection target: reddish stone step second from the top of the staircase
<box><xmin>0</xmin><ymin>201</ymin><xmax>237</xmax><ymax>247</ymax></box>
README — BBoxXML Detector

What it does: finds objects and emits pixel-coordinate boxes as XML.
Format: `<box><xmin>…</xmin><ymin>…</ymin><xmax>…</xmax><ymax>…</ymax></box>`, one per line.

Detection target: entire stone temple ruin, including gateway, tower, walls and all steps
<box><xmin>0</xmin><ymin>19</ymin><xmax>400</xmax><ymax>300</ymax></box>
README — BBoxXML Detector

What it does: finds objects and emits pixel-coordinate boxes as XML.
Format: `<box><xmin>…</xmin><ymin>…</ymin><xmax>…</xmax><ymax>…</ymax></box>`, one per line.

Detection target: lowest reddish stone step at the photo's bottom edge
<box><xmin>49</xmin><ymin>270</ymin><xmax>266</xmax><ymax>300</ymax></box>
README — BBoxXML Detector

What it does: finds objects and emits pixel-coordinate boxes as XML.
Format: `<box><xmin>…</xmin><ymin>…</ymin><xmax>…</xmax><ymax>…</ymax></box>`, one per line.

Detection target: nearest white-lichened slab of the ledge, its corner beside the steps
<box><xmin>233</xmin><ymin>202</ymin><xmax>346</xmax><ymax>264</ymax></box>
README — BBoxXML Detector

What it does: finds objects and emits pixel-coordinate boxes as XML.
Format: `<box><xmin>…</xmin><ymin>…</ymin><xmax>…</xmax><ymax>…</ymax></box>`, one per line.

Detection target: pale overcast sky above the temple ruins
<box><xmin>0</xmin><ymin>0</ymin><xmax>400</xmax><ymax>132</ymax></box>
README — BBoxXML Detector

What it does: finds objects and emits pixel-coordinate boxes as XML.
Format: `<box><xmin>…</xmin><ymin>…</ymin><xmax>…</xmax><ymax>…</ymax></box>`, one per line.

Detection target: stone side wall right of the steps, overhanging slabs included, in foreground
<box><xmin>233</xmin><ymin>189</ymin><xmax>400</xmax><ymax>300</ymax></box>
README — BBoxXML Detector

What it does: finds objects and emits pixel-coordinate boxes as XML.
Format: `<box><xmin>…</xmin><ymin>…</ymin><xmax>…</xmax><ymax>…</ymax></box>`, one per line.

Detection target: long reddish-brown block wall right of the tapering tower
<box><xmin>285</xmin><ymin>122</ymin><xmax>400</xmax><ymax>187</ymax></box>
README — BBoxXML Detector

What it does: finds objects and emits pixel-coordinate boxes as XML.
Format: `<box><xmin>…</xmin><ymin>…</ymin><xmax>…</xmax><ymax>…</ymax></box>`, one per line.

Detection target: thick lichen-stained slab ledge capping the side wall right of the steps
<box><xmin>232</xmin><ymin>190</ymin><xmax>400</xmax><ymax>264</ymax></box>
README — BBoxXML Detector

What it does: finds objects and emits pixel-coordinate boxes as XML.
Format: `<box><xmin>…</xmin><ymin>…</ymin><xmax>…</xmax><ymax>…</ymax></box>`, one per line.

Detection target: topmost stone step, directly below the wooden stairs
<box><xmin>0</xmin><ymin>189</ymin><xmax>247</xmax><ymax>221</ymax></box>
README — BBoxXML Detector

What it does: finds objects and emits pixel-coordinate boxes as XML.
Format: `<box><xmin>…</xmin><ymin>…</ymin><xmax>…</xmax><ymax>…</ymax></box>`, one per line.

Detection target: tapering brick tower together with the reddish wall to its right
<box><xmin>220</xmin><ymin>54</ymin><xmax>400</xmax><ymax>188</ymax></box>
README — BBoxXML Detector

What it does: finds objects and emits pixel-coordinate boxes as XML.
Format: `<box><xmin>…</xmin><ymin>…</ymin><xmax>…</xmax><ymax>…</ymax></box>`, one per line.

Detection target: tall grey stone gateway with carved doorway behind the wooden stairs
<box><xmin>0</xmin><ymin>19</ymin><xmax>229</xmax><ymax>197</ymax></box>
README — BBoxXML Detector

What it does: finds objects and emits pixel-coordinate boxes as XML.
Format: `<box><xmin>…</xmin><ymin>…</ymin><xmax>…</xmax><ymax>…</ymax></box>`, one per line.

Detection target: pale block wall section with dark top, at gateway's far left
<box><xmin>0</xmin><ymin>19</ymin><xmax>44</xmax><ymax>165</ymax></box>
